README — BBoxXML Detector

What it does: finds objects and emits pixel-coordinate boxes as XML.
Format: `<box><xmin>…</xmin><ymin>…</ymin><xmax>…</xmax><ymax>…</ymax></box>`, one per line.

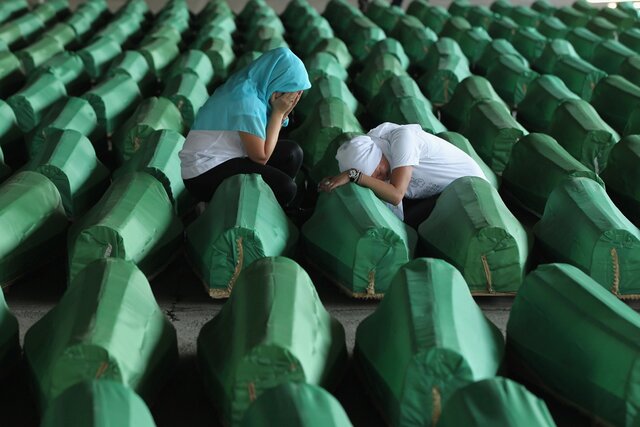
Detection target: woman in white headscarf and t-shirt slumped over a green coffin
<box><xmin>319</xmin><ymin>123</ymin><xmax>486</xmax><ymax>226</ymax></box>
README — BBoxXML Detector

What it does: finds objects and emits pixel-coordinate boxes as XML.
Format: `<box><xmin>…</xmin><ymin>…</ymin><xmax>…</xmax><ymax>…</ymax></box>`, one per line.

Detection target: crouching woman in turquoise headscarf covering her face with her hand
<box><xmin>180</xmin><ymin>48</ymin><xmax>311</xmax><ymax>206</ymax></box>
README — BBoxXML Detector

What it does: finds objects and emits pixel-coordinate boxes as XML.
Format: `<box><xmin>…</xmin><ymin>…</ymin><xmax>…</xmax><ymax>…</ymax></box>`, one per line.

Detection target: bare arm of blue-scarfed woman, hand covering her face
<box><xmin>238</xmin><ymin>92</ymin><xmax>301</xmax><ymax>165</ymax></box>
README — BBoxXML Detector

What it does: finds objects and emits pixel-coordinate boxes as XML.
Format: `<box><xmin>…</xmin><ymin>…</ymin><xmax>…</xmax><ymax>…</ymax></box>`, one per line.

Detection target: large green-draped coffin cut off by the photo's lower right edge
<box><xmin>507</xmin><ymin>264</ymin><xmax>640</xmax><ymax>426</ymax></box>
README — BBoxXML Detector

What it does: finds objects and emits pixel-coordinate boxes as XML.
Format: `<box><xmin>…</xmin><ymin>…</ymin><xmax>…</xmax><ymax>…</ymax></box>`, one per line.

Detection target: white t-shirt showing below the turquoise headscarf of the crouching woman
<box><xmin>179</xmin><ymin>130</ymin><xmax>248</xmax><ymax>179</ymax></box>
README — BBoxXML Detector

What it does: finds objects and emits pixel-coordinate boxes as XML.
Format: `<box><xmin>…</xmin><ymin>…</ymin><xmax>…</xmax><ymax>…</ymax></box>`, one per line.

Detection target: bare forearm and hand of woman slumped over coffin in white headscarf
<box><xmin>319</xmin><ymin>166</ymin><xmax>413</xmax><ymax>206</ymax></box>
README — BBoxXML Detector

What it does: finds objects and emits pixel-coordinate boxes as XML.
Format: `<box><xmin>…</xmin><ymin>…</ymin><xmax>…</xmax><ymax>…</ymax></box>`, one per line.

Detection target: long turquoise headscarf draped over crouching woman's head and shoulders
<box><xmin>191</xmin><ymin>47</ymin><xmax>311</xmax><ymax>139</ymax></box>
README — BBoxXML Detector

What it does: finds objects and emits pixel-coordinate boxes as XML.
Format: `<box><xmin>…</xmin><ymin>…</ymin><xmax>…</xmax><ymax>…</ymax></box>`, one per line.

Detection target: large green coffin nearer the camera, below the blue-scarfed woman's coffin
<box><xmin>198</xmin><ymin>257</ymin><xmax>347</xmax><ymax>426</ymax></box>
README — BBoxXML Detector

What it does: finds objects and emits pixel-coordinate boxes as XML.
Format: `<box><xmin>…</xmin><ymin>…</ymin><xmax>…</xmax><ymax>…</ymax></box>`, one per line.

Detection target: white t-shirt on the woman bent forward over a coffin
<box><xmin>367</xmin><ymin>123</ymin><xmax>487</xmax><ymax>199</ymax></box>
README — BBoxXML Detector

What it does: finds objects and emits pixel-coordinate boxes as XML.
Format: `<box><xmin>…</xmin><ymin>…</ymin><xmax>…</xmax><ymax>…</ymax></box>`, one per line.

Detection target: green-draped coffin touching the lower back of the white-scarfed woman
<box><xmin>460</xmin><ymin>100</ymin><xmax>527</xmax><ymax>175</ymax></box>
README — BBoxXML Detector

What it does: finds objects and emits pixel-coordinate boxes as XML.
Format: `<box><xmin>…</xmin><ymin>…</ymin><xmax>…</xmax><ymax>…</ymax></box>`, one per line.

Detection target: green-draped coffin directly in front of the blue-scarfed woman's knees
<box><xmin>182</xmin><ymin>174</ymin><xmax>298</xmax><ymax>298</ymax></box>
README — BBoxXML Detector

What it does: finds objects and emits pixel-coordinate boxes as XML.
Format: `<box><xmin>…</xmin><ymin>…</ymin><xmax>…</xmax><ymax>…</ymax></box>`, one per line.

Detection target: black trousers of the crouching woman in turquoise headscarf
<box><xmin>184</xmin><ymin>139</ymin><xmax>303</xmax><ymax>207</ymax></box>
